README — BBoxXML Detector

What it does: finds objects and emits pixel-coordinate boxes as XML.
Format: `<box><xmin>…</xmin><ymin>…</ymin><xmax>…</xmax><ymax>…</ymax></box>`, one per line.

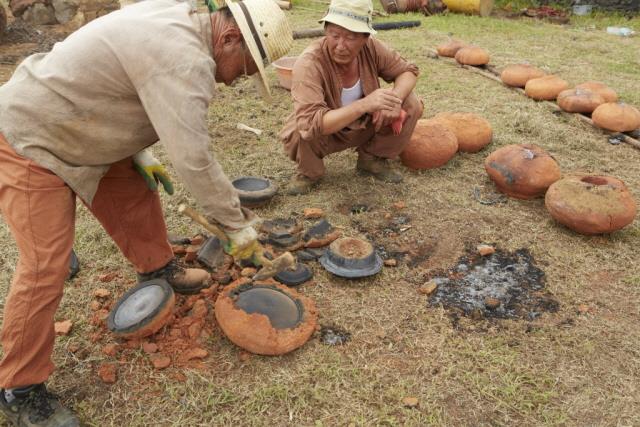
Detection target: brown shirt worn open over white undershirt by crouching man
<box><xmin>280</xmin><ymin>36</ymin><xmax>419</xmax><ymax>143</ymax></box>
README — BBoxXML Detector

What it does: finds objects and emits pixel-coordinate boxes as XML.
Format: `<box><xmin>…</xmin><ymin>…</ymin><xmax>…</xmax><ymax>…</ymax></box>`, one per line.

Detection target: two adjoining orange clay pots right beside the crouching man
<box><xmin>400</xmin><ymin>113</ymin><xmax>493</xmax><ymax>170</ymax></box>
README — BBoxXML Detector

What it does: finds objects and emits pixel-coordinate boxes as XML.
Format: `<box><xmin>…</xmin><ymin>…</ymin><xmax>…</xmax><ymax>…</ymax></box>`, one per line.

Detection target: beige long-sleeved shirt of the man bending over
<box><xmin>0</xmin><ymin>0</ymin><xmax>252</xmax><ymax>228</ymax></box>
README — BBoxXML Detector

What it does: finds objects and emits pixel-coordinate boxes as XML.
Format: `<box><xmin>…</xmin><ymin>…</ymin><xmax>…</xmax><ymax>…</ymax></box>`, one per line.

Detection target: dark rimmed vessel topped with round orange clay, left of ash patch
<box><xmin>320</xmin><ymin>237</ymin><xmax>382</xmax><ymax>279</ymax></box>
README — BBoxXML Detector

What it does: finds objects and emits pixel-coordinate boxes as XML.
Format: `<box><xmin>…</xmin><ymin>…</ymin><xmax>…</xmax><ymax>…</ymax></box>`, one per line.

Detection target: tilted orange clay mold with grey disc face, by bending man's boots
<box><xmin>107</xmin><ymin>279</ymin><xmax>175</xmax><ymax>339</ymax></box>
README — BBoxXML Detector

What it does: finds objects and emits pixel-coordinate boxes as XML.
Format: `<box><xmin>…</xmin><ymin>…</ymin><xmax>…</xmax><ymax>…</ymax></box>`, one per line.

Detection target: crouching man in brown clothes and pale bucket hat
<box><xmin>280</xmin><ymin>0</ymin><xmax>423</xmax><ymax>195</ymax></box>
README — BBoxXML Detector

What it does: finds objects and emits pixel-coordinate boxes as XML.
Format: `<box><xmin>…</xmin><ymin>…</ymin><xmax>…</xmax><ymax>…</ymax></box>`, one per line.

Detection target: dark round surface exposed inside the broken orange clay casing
<box><xmin>235</xmin><ymin>286</ymin><xmax>303</xmax><ymax>329</ymax></box>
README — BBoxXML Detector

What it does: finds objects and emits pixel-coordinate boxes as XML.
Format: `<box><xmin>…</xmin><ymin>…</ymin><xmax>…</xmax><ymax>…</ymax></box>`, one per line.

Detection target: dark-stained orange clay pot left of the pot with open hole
<box><xmin>484</xmin><ymin>144</ymin><xmax>560</xmax><ymax>199</ymax></box>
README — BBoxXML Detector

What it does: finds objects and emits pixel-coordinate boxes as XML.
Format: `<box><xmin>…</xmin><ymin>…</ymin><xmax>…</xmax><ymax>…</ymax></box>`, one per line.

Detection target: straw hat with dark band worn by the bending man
<box><xmin>227</xmin><ymin>0</ymin><xmax>293</xmax><ymax>96</ymax></box>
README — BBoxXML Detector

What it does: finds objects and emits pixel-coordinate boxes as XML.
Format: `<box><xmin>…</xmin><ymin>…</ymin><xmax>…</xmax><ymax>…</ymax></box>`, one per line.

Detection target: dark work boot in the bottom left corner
<box><xmin>0</xmin><ymin>384</ymin><xmax>80</xmax><ymax>427</ymax></box>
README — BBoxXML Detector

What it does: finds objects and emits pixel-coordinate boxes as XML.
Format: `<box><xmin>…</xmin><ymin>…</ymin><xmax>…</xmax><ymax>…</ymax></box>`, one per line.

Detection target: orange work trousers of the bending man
<box><xmin>0</xmin><ymin>134</ymin><xmax>173</xmax><ymax>388</ymax></box>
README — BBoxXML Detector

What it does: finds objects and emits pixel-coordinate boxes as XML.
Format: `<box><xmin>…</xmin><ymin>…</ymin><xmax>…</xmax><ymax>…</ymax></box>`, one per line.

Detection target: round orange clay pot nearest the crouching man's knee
<box><xmin>400</xmin><ymin>119</ymin><xmax>458</xmax><ymax>170</ymax></box>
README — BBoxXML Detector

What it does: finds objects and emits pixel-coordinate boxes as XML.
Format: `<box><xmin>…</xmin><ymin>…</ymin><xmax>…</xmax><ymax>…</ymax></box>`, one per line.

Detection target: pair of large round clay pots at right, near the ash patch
<box><xmin>484</xmin><ymin>144</ymin><xmax>637</xmax><ymax>235</ymax></box>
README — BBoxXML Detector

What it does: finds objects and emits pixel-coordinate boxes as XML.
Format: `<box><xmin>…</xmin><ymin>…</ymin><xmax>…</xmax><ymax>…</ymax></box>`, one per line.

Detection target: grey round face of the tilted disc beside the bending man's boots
<box><xmin>107</xmin><ymin>279</ymin><xmax>173</xmax><ymax>334</ymax></box>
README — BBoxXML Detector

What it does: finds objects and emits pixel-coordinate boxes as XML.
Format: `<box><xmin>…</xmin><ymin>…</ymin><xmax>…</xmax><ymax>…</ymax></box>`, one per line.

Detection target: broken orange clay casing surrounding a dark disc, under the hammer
<box><xmin>215</xmin><ymin>279</ymin><xmax>318</xmax><ymax>356</ymax></box>
